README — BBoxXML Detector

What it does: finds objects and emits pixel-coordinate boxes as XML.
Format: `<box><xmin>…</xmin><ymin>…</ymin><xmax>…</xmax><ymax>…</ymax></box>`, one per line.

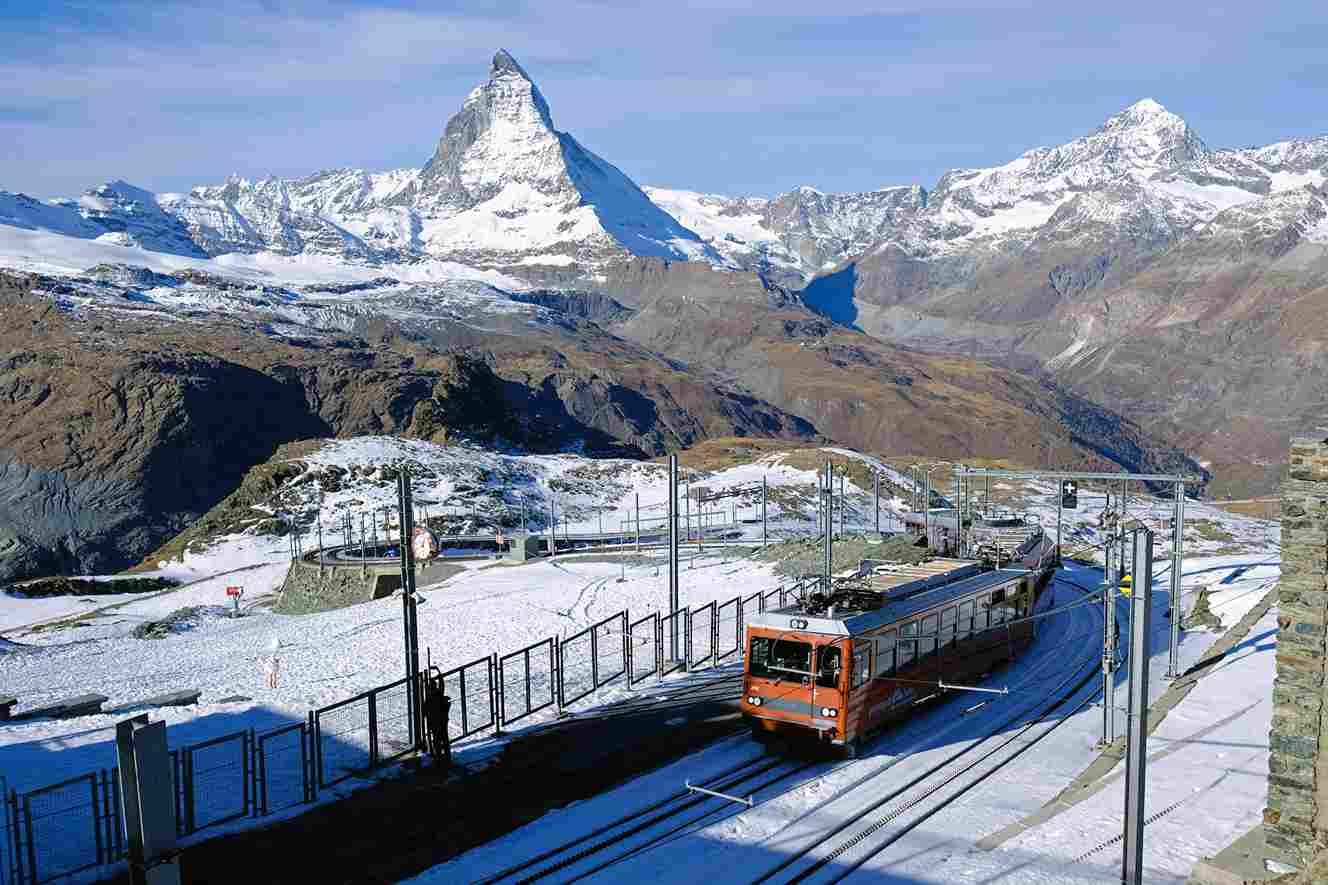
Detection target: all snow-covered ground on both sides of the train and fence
<box><xmin>0</xmin><ymin>437</ymin><xmax>1279</xmax><ymax>881</ymax></box>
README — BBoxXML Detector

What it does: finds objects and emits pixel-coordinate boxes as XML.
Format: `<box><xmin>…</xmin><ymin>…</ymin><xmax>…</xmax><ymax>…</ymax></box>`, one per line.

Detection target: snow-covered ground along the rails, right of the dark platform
<box><xmin>412</xmin><ymin>555</ymin><xmax>1279</xmax><ymax>884</ymax></box>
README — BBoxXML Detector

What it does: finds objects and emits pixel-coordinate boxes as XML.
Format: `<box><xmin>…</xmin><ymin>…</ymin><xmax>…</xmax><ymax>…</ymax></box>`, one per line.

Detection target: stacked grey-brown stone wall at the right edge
<box><xmin>1264</xmin><ymin>435</ymin><xmax>1328</xmax><ymax>865</ymax></box>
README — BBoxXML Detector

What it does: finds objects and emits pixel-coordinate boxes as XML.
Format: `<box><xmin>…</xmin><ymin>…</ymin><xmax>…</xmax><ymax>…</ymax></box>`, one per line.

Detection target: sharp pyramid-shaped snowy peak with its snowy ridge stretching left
<box><xmin>0</xmin><ymin>50</ymin><xmax>722</xmax><ymax>278</ymax></box>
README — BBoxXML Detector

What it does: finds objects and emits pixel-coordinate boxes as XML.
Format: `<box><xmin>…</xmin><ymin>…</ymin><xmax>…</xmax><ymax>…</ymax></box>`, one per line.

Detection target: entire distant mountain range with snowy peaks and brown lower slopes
<box><xmin>0</xmin><ymin>52</ymin><xmax>1328</xmax><ymax>574</ymax></box>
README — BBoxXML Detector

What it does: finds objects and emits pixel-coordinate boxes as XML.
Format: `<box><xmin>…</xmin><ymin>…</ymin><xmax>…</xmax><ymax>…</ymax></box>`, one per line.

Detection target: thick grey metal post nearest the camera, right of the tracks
<box><xmin>1121</xmin><ymin>529</ymin><xmax>1153</xmax><ymax>885</ymax></box>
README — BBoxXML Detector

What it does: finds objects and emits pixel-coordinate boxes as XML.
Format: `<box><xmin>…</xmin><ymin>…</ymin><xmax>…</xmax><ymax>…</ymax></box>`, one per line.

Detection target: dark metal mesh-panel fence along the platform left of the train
<box><xmin>0</xmin><ymin>576</ymin><xmax>806</xmax><ymax>885</ymax></box>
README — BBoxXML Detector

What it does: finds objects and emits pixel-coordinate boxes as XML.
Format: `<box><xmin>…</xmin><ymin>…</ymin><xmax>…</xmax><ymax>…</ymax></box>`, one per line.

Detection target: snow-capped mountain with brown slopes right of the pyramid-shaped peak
<box><xmin>738</xmin><ymin>100</ymin><xmax>1328</xmax><ymax>494</ymax></box>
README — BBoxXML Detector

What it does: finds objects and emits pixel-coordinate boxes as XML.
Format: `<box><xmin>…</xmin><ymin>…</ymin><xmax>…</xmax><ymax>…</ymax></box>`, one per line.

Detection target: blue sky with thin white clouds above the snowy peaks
<box><xmin>0</xmin><ymin>0</ymin><xmax>1328</xmax><ymax>197</ymax></box>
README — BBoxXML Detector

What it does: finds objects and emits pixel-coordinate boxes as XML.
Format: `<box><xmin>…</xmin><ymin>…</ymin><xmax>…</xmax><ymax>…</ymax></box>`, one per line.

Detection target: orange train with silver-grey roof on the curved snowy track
<box><xmin>742</xmin><ymin>559</ymin><xmax>1050</xmax><ymax>756</ymax></box>
